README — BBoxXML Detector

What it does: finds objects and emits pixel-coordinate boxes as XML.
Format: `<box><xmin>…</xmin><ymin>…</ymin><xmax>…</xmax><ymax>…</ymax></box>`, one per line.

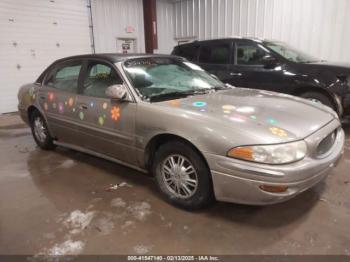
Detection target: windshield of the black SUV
<box><xmin>265</xmin><ymin>42</ymin><xmax>319</xmax><ymax>63</ymax></box>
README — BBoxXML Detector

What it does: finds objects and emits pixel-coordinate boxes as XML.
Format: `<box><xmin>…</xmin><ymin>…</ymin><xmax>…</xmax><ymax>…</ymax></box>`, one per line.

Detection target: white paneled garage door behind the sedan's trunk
<box><xmin>0</xmin><ymin>0</ymin><xmax>91</xmax><ymax>113</ymax></box>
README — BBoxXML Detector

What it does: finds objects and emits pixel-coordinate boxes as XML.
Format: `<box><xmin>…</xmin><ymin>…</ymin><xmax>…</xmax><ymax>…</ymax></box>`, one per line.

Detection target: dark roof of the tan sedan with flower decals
<box><xmin>56</xmin><ymin>53</ymin><xmax>179</xmax><ymax>63</ymax></box>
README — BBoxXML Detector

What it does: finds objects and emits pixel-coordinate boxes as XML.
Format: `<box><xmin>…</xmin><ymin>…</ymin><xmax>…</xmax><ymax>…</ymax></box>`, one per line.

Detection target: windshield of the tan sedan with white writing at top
<box><xmin>124</xmin><ymin>57</ymin><xmax>227</xmax><ymax>101</ymax></box>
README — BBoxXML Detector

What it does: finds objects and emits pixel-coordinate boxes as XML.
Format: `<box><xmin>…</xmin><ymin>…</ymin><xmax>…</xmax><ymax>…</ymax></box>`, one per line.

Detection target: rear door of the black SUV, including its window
<box><xmin>198</xmin><ymin>40</ymin><xmax>233</xmax><ymax>82</ymax></box>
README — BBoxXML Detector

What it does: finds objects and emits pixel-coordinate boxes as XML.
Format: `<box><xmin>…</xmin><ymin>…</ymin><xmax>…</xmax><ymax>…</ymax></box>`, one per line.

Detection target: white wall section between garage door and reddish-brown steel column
<box><xmin>92</xmin><ymin>0</ymin><xmax>145</xmax><ymax>53</ymax></box>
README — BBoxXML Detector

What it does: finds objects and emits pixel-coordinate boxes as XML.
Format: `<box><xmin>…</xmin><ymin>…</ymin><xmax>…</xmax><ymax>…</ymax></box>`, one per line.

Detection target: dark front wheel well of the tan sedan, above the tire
<box><xmin>145</xmin><ymin>134</ymin><xmax>209</xmax><ymax>173</ymax></box>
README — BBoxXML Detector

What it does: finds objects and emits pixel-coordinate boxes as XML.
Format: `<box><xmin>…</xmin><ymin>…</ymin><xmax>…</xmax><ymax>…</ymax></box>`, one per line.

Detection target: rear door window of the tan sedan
<box><xmin>45</xmin><ymin>61</ymin><xmax>82</xmax><ymax>93</ymax></box>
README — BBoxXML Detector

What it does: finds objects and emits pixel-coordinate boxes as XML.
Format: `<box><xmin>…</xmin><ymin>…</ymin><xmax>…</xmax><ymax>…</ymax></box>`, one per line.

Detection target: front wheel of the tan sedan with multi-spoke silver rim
<box><xmin>152</xmin><ymin>141</ymin><xmax>214</xmax><ymax>210</ymax></box>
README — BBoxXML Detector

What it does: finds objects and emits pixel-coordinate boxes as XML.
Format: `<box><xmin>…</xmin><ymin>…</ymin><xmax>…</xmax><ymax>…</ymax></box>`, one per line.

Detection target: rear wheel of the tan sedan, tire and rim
<box><xmin>30</xmin><ymin>110</ymin><xmax>56</xmax><ymax>150</ymax></box>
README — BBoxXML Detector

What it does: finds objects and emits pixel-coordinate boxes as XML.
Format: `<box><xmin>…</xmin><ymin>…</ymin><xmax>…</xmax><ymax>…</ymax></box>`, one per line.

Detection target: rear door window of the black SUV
<box><xmin>199</xmin><ymin>43</ymin><xmax>230</xmax><ymax>64</ymax></box>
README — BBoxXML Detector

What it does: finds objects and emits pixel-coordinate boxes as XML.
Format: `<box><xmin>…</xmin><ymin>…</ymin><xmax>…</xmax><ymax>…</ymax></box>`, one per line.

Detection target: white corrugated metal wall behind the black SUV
<box><xmin>174</xmin><ymin>0</ymin><xmax>350</xmax><ymax>62</ymax></box>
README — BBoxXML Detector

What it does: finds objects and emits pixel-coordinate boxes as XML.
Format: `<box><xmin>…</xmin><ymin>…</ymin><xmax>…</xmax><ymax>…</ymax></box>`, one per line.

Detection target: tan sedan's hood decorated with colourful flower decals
<box><xmin>154</xmin><ymin>88</ymin><xmax>335</xmax><ymax>143</ymax></box>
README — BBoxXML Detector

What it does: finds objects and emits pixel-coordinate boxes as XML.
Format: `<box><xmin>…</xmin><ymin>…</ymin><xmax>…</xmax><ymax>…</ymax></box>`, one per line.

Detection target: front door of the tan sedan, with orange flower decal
<box><xmin>77</xmin><ymin>60</ymin><xmax>136</xmax><ymax>164</ymax></box>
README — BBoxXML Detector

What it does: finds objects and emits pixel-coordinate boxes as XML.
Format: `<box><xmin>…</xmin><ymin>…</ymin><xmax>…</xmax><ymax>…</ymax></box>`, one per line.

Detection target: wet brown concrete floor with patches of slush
<box><xmin>0</xmin><ymin>113</ymin><xmax>350</xmax><ymax>255</ymax></box>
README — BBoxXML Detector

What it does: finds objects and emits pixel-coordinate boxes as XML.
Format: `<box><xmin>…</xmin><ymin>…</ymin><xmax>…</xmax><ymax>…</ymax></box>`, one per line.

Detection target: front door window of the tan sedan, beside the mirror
<box><xmin>83</xmin><ymin>62</ymin><xmax>123</xmax><ymax>97</ymax></box>
